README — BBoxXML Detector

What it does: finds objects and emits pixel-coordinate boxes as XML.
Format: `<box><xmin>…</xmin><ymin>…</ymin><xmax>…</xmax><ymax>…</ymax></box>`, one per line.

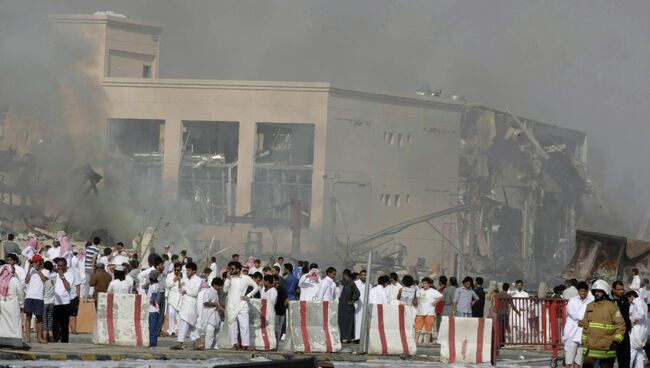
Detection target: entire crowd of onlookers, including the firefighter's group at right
<box><xmin>0</xmin><ymin>232</ymin><xmax>650</xmax><ymax>367</ymax></box>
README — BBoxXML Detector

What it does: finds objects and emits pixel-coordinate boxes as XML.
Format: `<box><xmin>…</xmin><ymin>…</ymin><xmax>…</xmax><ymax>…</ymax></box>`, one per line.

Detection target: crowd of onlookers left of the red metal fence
<box><xmin>0</xmin><ymin>232</ymin><xmax>494</xmax><ymax>350</ymax></box>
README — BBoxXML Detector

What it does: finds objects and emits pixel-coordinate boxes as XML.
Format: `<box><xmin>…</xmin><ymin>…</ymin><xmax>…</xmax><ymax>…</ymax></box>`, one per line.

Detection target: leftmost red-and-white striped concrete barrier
<box><xmin>92</xmin><ymin>293</ymin><xmax>149</xmax><ymax>346</ymax></box>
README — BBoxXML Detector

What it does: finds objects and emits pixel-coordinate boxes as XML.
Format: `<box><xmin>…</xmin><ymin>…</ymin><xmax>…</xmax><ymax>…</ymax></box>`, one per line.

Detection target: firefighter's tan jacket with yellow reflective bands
<box><xmin>582</xmin><ymin>299</ymin><xmax>625</xmax><ymax>359</ymax></box>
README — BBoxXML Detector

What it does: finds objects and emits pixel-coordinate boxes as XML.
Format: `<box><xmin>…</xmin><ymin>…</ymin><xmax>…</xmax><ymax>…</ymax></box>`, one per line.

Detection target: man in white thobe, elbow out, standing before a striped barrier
<box><xmin>223</xmin><ymin>261</ymin><xmax>259</xmax><ymax>350</ymax></box>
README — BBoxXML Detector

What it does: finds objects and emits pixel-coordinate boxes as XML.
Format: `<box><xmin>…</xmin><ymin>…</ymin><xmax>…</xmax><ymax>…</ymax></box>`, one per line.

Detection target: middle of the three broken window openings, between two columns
<box><xmin>179</xmin><ymin>121</ymin><xmax>239</xmax><ymax>224</ymax></box>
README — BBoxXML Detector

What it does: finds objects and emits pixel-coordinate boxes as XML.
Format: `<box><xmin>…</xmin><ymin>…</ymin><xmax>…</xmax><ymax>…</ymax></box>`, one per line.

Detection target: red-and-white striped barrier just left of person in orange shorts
<box><xmin>368</xmin><ymin>304</ymin><xmax>417</xmax><ymax>356</ymax></box>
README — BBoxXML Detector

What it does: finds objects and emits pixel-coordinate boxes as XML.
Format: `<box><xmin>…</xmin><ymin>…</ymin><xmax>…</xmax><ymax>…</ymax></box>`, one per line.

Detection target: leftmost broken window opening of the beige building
<box><xmin>105</xmin><ymin>119</ymin><xmax>165</xmax><ymax>198</ymax></box>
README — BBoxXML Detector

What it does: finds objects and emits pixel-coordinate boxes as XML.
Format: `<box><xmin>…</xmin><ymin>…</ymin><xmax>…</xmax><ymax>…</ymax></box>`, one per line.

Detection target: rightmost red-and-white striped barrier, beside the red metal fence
<box><xmin>438</xmin><ymin>316</ymin><xmax>492</xmax><ymax>364</ymax></box>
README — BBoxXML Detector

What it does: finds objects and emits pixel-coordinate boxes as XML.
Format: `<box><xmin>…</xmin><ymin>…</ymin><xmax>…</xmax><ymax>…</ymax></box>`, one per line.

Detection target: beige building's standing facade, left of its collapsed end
<box><xmin>6</xmin><ymin>13</ymin><xmax>584</xmax><ymax>280</ymax></box>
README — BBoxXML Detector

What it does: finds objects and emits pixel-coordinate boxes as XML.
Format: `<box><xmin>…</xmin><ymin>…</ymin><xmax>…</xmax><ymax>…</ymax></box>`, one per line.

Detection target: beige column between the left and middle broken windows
<box><xmin>162</xmin><ymin>118</ymin><xmax>183</xmax><ymax>199</ymax></box>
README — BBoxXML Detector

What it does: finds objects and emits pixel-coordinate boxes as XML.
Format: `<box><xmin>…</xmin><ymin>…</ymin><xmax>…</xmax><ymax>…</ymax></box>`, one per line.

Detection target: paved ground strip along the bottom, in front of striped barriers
<box><xmin>0</xmin><ymin>334</ymin><xmax>551</xmax><ymax>368</ymax></box>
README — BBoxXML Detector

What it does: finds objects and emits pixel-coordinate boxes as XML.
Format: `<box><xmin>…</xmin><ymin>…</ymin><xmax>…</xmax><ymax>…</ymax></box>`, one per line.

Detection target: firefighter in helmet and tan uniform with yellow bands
<box><xmin>580</xmin><ymin>280</ymin><xmax>625</xmax><ymax>368</ymax></box>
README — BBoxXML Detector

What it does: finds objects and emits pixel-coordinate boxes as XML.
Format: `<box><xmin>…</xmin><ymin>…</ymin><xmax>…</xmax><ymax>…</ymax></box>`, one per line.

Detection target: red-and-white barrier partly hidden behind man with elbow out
<box><xmin>217</xmin><ymin>299</ymin><xmax>277</xmax><ymax>351</ymax></box>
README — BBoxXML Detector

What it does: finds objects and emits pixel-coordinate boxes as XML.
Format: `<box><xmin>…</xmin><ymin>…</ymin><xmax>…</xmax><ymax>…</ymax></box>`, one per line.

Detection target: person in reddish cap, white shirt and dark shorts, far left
<box><xmin>23</xmin><ymin>254</ymin><xmax>50</xmax><ymax>343</ymax></box>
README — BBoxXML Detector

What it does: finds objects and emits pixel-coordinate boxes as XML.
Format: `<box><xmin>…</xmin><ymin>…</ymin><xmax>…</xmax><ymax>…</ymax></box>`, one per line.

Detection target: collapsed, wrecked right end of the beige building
<box><xmin>459</xmin><ymin>107</ymin><xmax>590</xmax><ymax>278</ymax></box>
